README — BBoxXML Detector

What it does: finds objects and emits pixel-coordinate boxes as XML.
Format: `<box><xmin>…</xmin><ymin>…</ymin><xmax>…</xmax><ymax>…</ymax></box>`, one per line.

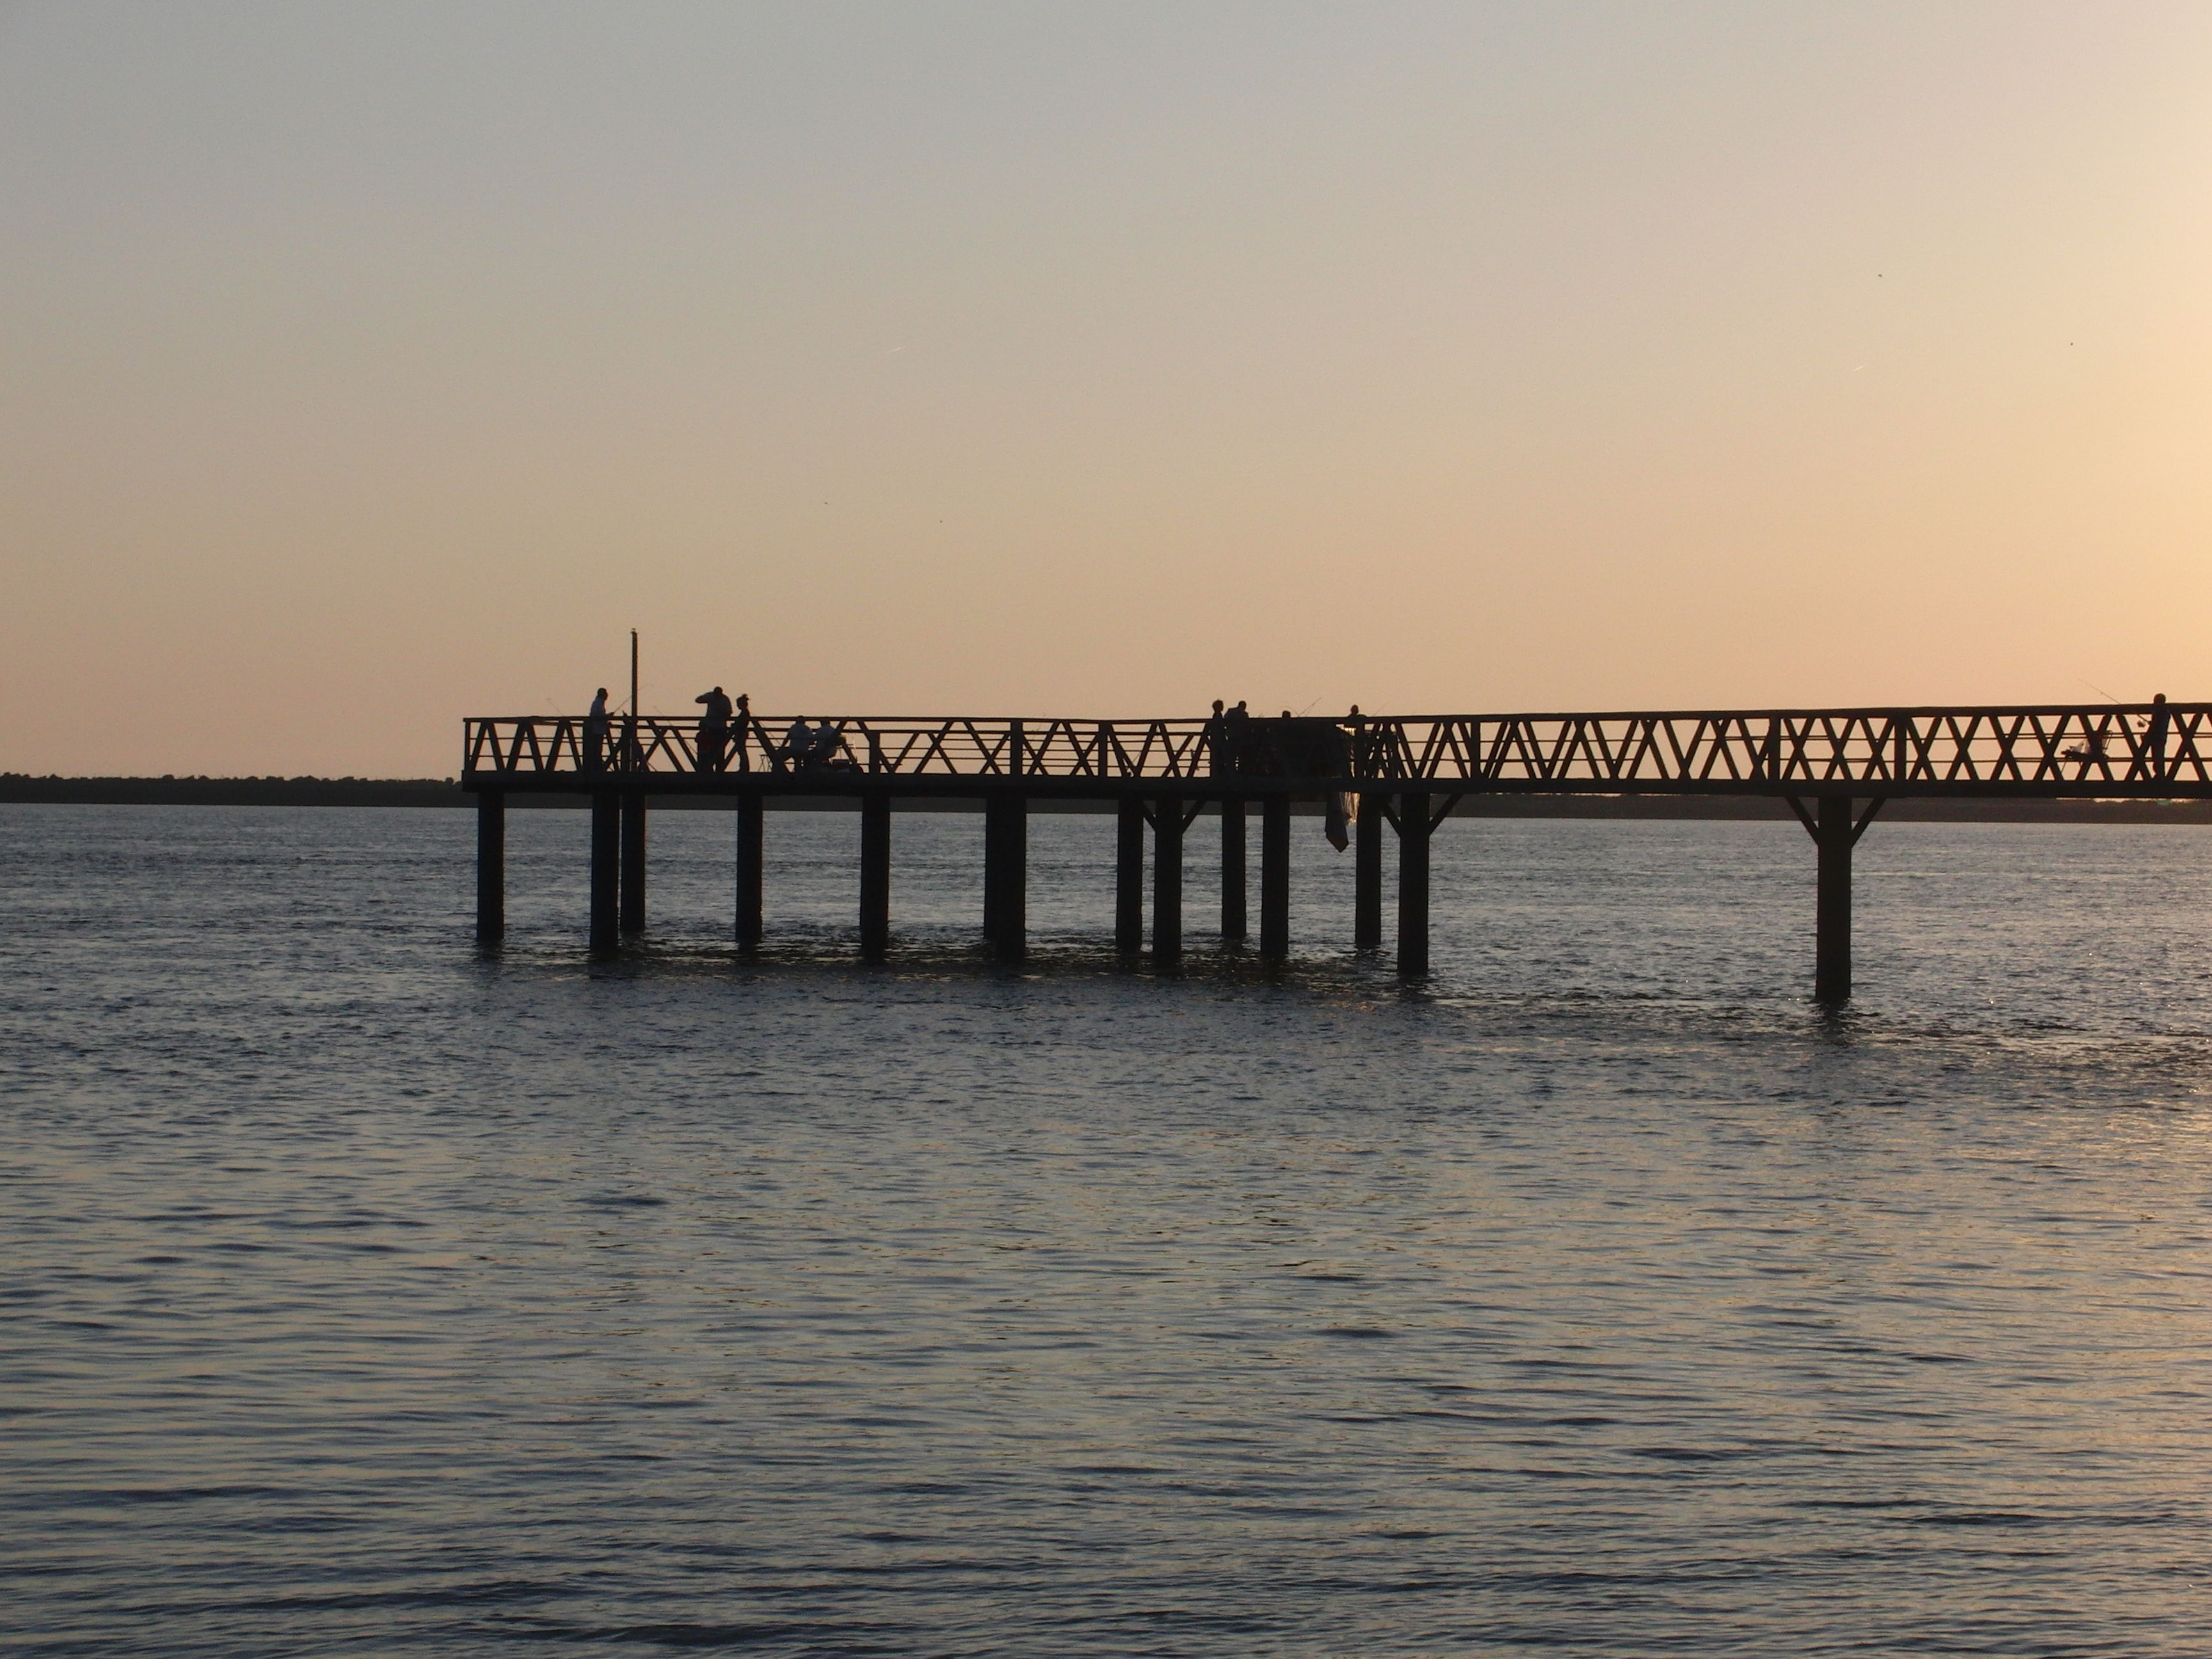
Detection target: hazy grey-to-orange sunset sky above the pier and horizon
<box><xmin>0</xmin><ymin>0</ymin><xmax>2212</xmax><ymax>776</ymax></box>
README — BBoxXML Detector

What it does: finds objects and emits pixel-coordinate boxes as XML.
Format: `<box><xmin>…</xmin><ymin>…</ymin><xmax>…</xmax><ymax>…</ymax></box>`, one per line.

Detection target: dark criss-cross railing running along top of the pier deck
<box><xmin>462</xmin><ymin>703</ymin><xmax>2212</xmax><ymax>794</ymax></box>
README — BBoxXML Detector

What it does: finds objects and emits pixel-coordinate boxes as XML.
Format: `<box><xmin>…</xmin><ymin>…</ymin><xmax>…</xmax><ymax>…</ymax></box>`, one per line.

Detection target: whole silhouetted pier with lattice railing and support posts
<box><xmin>462</xmin><ymin>697</ymin><xmax>2212</xmax><ymax>1002</ymax></box>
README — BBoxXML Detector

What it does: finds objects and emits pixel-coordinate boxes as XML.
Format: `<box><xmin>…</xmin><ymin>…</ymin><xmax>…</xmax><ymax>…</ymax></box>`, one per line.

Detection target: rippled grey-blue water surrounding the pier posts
<box><xmin>0</xmin><ymin>807</ymin><xmax>2212</xmax><ymax>1657</ymax></box>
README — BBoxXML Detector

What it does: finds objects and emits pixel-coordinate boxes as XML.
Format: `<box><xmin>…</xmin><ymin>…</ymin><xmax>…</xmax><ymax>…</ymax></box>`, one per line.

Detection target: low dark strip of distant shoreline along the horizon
<box><xmin>0</xmin><ymin>772</ymin><xmax>2212</xmax><ymax>823</ymax></box>
